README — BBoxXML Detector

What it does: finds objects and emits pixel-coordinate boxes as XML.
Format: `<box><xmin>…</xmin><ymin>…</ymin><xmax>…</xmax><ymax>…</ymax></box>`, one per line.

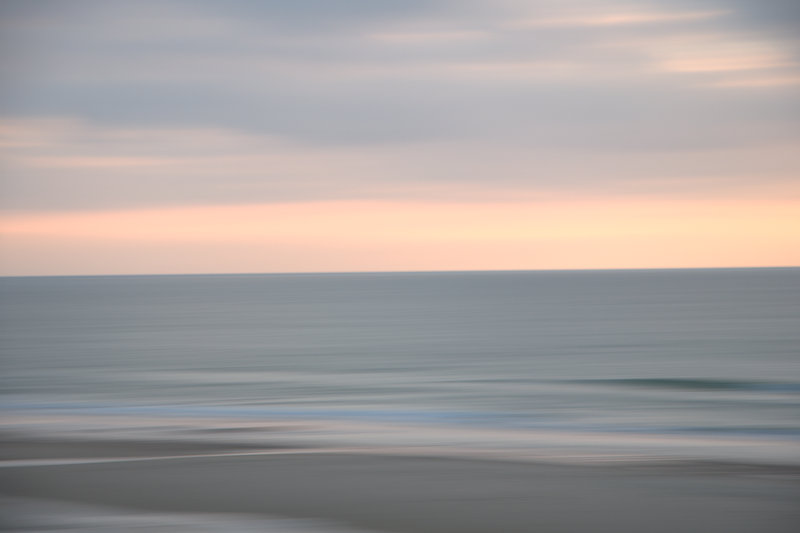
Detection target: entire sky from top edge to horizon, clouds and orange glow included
<box><xmin>0</xmin><ymin>0</ymin><xmax>800</xmax><ymax>275</ymax></box>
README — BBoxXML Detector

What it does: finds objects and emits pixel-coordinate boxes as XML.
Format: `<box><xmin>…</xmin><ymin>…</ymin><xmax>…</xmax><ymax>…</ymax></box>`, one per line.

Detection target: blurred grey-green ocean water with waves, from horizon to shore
<box><xmin>0</xmin><ymin>268</ymin><xmax>800</xmax><ymax>463</ymax></box>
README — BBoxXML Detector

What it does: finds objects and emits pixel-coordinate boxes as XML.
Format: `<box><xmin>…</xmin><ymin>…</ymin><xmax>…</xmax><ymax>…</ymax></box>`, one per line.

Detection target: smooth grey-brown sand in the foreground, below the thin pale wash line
<box><xmin>0</xmin><ymin>436</ymin><xmax>800</xmax><ymax>533</ymax></box>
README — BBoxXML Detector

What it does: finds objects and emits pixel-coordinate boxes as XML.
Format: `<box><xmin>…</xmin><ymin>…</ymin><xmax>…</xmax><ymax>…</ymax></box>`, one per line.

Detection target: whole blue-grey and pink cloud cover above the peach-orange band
<box><xmin>0</xmin><ymin>0</ymin><xmax>800</xmax><ymax>210</ymax></box>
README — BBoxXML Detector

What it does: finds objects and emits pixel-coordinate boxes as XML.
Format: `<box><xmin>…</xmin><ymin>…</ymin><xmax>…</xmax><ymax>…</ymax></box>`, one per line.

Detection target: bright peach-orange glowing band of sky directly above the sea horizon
<box><xmin>3</xmin><ymin>198</ymin><xmax>800</xmax><ymax>275</ymax></box>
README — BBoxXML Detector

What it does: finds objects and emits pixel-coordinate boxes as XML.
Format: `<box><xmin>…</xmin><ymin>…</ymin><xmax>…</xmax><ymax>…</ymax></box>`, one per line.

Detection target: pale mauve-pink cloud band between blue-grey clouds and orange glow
<box><xmin>0</xmin><ymin>119</ymin><xmax>800</xmax><ymax>211</ymax></box>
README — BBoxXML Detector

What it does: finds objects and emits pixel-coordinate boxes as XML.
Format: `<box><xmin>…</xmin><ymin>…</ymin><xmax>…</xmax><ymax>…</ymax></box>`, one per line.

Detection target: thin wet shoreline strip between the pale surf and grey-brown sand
<box><xmin>0</xmin><ymin>432</ymin><xmax>800</xmax><ymax>474</ymax></box>
